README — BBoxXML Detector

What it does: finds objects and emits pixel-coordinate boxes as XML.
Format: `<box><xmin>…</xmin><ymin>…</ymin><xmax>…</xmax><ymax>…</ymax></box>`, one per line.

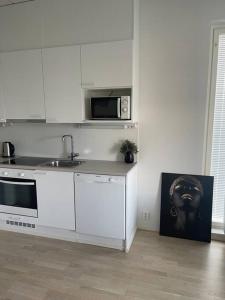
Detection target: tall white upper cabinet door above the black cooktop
<box><xmin>1</xmin><ymin>49</ymin><xmax>45</xmax><ymax>119</ymax></box>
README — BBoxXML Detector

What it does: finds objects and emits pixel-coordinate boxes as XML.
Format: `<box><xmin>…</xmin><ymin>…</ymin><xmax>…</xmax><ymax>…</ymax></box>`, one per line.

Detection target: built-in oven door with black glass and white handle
<box><xmin>0</xmin><ymin>177</ymin><xmax>38</xmax><ymax>217</ymax></box>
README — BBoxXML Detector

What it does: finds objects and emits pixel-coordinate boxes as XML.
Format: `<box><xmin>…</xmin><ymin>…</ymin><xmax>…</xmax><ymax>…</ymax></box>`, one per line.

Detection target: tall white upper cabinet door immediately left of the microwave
<box><xmin>42</xmin><ymin>46</ymin><xmax>83</xmax><ymax>123</ymax></box>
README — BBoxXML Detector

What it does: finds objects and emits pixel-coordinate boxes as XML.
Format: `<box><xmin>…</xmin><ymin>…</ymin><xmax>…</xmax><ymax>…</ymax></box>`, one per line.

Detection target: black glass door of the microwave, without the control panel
<box><xmin>91</xmin><ymin>97</ymin><xmax>121</xmax><ymax>120</ymax></box>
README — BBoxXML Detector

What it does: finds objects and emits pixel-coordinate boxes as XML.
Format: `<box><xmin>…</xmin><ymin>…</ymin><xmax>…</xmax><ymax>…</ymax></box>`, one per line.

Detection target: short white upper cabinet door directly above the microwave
<box><xmin>81</xmin><ymin>41</ymin><xmax>132</xmax><ymax>88</ymax></box>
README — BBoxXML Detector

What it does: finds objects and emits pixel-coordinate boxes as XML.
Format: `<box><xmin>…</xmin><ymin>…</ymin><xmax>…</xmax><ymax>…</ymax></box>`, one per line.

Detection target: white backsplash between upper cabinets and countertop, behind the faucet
<box><xmin>0</xmin><ymin>123</ymin><xmax>138</xmax><ymax>161</ymax></box>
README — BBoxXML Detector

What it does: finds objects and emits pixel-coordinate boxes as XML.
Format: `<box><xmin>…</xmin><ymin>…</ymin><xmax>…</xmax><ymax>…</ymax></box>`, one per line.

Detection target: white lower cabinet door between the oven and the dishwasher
<box><xmin>35</xmin><ymin>171</ymin><xmax>75</xmax><ymax>230</ymax></box>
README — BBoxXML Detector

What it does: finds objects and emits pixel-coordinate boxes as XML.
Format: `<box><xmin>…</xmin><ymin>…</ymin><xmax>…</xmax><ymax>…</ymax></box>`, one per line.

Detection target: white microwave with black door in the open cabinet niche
<box><xmin>90</xmin><ymin>96</ymin><xmax>131</xmax><ymax>120</ymax></box>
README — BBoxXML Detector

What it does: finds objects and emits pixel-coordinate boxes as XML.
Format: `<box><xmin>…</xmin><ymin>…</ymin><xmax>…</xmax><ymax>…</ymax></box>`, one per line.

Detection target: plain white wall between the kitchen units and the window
<box><xmin>139</xmin><ymin>0</ymin><xmax>225</xmax><ymax>230</ymax></box>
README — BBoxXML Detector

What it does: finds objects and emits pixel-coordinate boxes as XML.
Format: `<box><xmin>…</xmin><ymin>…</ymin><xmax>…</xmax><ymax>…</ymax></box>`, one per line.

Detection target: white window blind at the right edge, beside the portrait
<box><xmin>210</xmin><ymin>33</ymin><xmax>225</xmax><ymax>224</ymax></box>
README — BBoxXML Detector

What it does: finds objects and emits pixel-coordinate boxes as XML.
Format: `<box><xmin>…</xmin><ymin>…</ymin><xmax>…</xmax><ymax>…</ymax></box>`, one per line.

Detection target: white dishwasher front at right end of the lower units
<box><xmin>75</xmin><ymin>173</ymin><xmax>125</xmax><ymax>239</ymax></box>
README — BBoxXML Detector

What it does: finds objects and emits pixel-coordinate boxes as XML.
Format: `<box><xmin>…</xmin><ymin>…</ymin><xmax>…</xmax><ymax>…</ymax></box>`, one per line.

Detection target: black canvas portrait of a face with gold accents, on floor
<box><xmin>160</xmin><ymin>173</ymin><xmax>213</xmax><ymax>242</ymax></box>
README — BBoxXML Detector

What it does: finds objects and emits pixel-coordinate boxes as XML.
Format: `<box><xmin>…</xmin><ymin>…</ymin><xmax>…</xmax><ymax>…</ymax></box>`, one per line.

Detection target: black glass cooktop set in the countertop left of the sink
<box><xmin>2</xmin><ymin>156</ymin><xmax>51</xmax><ymax>166</ymax></box>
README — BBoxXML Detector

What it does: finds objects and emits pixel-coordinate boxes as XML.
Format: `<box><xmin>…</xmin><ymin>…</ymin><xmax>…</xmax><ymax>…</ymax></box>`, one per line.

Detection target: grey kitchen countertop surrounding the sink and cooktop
<box><xmin>0</xmin><ymin>158</ymin><xmax>136</xmax><ymax>176</ymax></box>
